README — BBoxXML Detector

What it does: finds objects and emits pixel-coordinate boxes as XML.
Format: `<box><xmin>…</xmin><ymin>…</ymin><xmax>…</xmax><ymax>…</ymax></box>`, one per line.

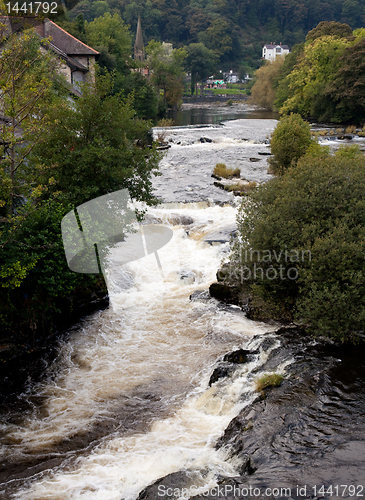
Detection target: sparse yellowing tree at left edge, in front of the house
<box><xmin>0</xmin><ymin>25</ymin><xmax>66</xmax><ymax>220</ymax></box>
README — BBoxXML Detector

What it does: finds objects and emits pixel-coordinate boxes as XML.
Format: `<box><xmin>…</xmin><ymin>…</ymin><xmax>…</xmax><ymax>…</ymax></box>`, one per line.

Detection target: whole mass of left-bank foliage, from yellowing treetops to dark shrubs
<box><xmin>0</xmin><ymin>32</ymin><xmax>161</xmax><ymax>348</ymax></box>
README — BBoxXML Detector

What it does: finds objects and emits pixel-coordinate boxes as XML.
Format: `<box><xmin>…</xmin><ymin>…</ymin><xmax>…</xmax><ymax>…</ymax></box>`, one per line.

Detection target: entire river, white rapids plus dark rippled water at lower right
<box><xmin>0</xmin><ymin>106</ymin><xmax>365</xmax><ymax>500</ymax></box>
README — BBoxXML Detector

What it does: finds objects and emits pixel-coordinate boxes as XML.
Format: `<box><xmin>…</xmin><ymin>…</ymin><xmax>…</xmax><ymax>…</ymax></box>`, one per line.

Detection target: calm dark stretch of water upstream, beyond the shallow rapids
<box><xmin>170</xmin><ymin>104</ymin><xmax>279</xmax><ymax>127</ymax></box>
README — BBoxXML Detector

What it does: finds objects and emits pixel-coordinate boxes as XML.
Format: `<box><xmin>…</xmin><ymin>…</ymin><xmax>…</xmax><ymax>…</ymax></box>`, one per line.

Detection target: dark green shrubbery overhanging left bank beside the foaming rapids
<box><xmin>0</xmin><ymin>202</ymin><xmax>104</xmax><ymax>338</ymax></box>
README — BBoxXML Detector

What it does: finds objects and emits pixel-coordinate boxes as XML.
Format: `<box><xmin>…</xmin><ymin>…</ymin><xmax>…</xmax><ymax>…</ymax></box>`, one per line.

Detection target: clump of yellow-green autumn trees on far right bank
<box><xmin>251</xmin><ymin>22</ymin><xmax>365</xmax><ymax>125</ymax></box>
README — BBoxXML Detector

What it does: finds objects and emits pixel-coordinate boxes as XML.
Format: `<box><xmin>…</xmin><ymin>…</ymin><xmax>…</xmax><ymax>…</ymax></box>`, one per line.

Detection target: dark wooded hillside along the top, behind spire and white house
<box><xmin>61</xmin><ymin>0</ymin><xmax>365</xmax><ymax>72</ymax></box>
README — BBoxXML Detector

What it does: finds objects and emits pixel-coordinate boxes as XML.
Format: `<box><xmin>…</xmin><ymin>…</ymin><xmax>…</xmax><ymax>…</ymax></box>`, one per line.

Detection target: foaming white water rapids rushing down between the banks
<box><xmin>0</xmin><ymin>112</ymin><xmax>284</xmax><ymax>500</ymax></box>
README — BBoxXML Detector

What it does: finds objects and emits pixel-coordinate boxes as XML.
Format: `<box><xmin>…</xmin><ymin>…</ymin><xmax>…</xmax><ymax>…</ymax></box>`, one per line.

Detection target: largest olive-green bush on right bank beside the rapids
<box><xmin>231</xmin><ymin>146</ymin><xmax>365</xmax><ymax>341</ymax></box>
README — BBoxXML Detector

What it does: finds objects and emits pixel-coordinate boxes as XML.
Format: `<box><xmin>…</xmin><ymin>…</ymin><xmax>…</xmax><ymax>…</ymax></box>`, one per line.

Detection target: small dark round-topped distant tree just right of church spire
<box><xmin>185</xmin><ymin>43</ymin><xmax>217</xmax><ymax>95</ymax></box>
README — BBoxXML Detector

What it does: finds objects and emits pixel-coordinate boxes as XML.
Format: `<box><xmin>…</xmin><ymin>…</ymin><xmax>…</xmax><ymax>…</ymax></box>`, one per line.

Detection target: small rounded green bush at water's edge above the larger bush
<box><xmin>269</xmin><ymin>113</ymin><xmax>313</xmax><ymax>175</ymax></box>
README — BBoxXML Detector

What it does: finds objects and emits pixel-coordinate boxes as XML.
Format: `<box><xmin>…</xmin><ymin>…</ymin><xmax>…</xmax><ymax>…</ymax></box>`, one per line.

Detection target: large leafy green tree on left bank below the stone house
<box><xmin>29</xmin><ymin>75</ymin><xmax>161</xmax><ymax>206</ymax></box>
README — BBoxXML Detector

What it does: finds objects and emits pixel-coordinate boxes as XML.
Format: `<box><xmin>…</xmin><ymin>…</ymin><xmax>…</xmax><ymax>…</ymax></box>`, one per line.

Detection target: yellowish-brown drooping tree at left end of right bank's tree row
<box><xmin>249</xmin><ymin>57</ymin><xmax>284</xmax><ymax>110</ymax></box>
